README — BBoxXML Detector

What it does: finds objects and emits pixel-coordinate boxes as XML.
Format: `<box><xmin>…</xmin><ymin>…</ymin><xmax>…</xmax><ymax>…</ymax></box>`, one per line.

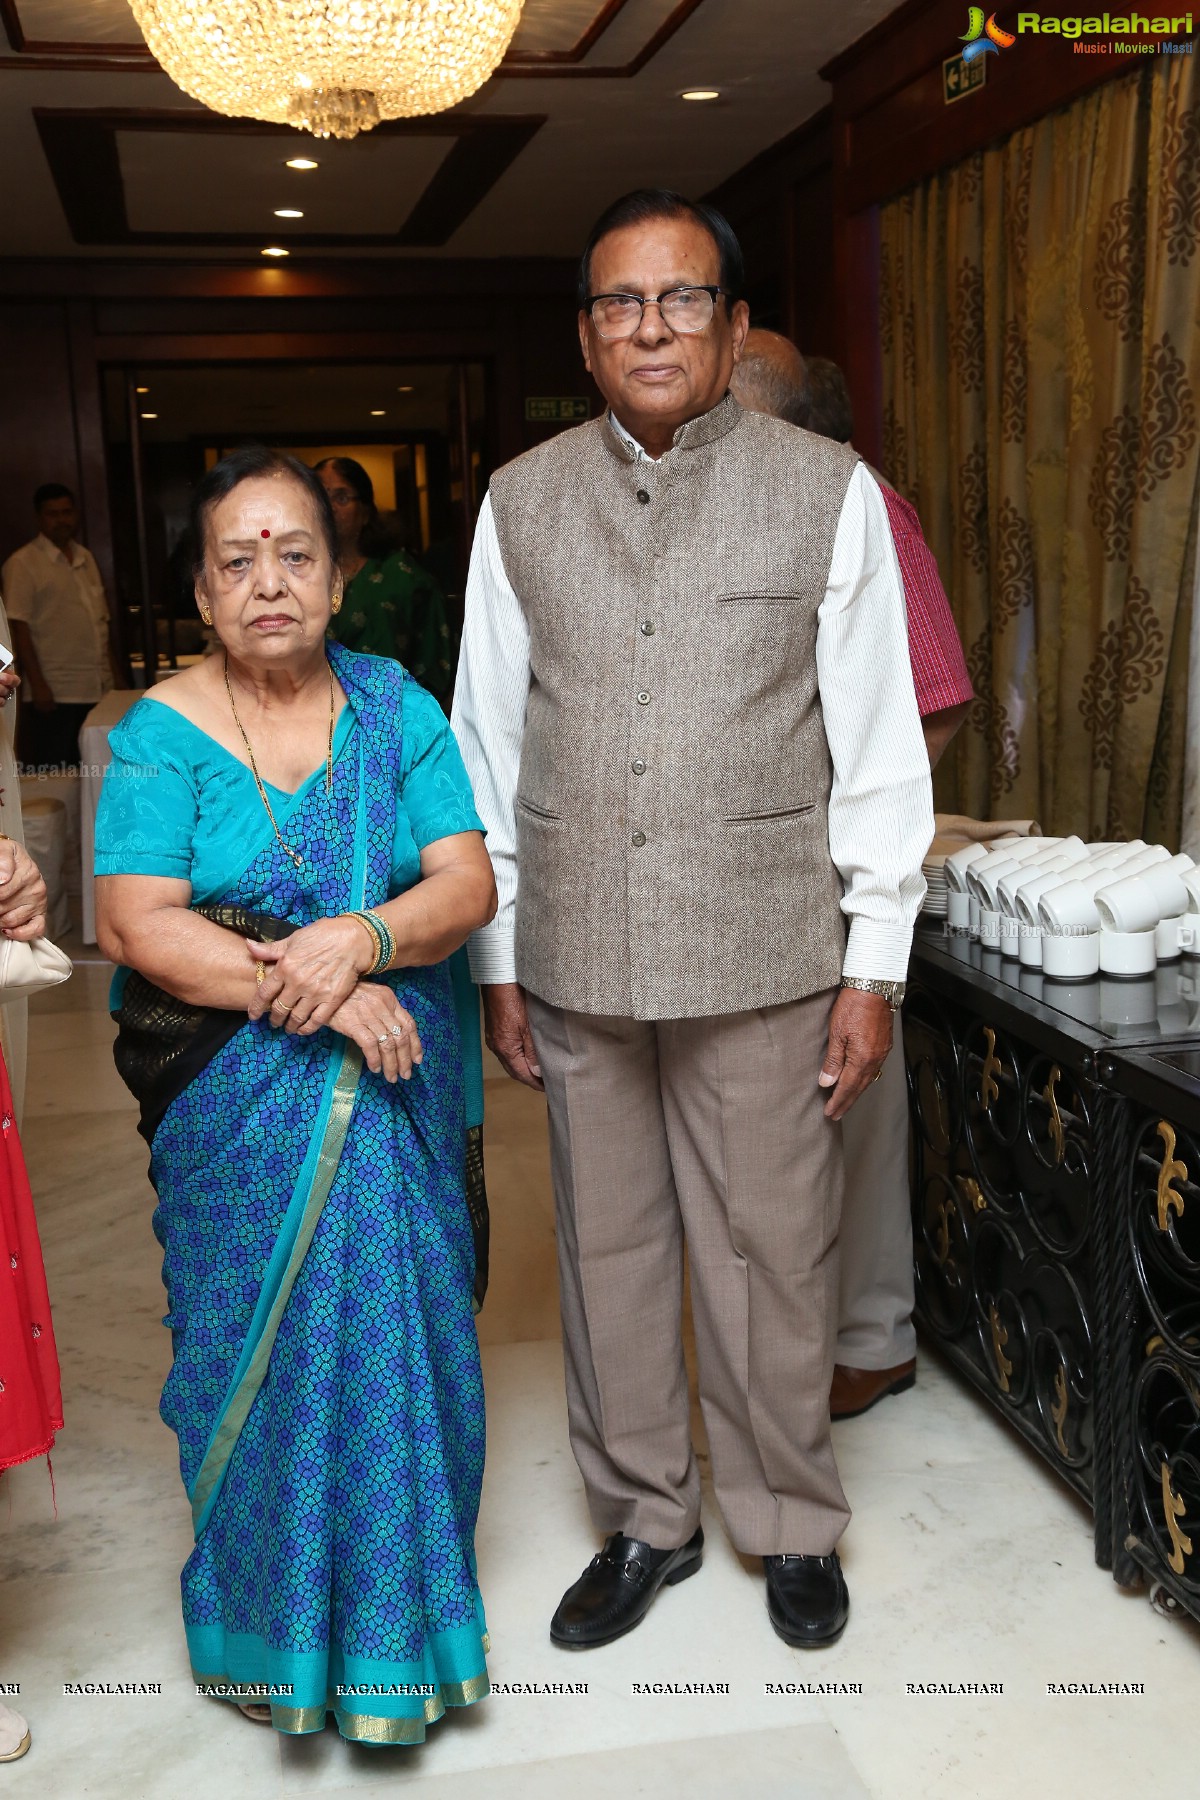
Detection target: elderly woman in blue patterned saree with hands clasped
<box><xmin>95</xmin><ymin>448</ymin><xmax>495</xmax><ymax>1744</ymax></box>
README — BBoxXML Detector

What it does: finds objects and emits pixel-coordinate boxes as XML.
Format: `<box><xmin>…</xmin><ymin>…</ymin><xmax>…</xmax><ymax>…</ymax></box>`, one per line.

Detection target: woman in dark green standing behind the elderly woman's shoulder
<box><xmin>315</xmin><ymin>455</ymin><xmax>455</xmax><ymax>713</ymax></box>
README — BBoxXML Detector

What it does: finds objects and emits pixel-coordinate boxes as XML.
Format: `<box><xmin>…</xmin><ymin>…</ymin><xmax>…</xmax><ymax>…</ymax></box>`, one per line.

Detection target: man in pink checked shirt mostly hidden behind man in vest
<box><xmin>730</xmin><ymin>329</ymin><xmax>973</xmax><ymax>1418</ymax></box>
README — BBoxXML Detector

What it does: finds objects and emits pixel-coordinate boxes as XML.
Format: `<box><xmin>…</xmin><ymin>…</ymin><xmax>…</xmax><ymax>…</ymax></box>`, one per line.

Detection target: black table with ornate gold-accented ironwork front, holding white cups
<box><xmin>903</xmin><ymin>925</ymin><xmax>1200</xmax><ymax>1616</ymax></box>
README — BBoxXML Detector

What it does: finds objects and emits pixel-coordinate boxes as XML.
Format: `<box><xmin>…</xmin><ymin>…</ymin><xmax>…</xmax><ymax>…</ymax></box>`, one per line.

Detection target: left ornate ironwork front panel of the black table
<box><xmin>905</xmin><ymin>976</ymin><xmax>1106</xmax><ymax>1519</ymax></box>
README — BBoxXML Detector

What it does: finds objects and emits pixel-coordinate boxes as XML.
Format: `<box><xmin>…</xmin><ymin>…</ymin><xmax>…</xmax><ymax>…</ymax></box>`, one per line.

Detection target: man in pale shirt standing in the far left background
<box><xmin>0</xmin><ymin>482</ymin><xmax>117</xmax><ymax>772</ymax></box>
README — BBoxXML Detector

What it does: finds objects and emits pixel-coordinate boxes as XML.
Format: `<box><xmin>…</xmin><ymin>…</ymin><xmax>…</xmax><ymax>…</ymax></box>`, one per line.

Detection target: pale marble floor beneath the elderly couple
<box><xmin>0</xmin><ymin>952</ymin><xmax>1200</xmax><ymax>1800</ymax></box>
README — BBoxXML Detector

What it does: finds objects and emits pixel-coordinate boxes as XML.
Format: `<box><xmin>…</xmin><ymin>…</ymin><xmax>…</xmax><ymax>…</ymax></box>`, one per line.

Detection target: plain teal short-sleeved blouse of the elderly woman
<box><xmin>95</xmin><ymin>680</ymin><xmax>484</xmax><ymax>1125</ymax></box>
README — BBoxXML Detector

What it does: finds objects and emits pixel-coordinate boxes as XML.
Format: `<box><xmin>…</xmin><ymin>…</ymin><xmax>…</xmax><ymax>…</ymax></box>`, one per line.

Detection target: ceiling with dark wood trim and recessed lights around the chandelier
<box><xmin>0</xmin><ymin>0</ymin><xmax>906</xmax><ymax>261</ymax></box>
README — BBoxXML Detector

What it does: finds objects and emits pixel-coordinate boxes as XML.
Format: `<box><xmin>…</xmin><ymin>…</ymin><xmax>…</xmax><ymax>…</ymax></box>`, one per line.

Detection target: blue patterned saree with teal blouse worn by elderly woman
<box><xmin>97</xmin><ymin>646</ymin><xmax>488</xmax><ymax>1744</ymax></box>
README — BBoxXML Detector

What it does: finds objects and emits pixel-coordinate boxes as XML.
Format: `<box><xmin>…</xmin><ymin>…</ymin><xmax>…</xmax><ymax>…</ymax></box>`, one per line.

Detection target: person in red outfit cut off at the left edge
<box><xmin>0</xmin><ymin>837</ymin><xmax>63</xmax><ymax>1762</ymax></box>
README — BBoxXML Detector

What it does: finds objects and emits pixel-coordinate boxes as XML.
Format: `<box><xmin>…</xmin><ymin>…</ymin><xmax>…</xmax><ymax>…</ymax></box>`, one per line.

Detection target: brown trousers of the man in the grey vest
<box><xmin>529</xmin><ymin>992</ymin><xmax>849</xmax><ymax>1555</ymax></box>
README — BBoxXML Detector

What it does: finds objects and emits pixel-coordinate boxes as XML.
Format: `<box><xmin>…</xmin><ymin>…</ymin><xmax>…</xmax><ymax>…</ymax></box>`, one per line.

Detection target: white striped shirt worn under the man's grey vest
<box><xmin>450</xmin><ymin>444</ymin><xmax>934</xmax><ymax>983</ymax></box>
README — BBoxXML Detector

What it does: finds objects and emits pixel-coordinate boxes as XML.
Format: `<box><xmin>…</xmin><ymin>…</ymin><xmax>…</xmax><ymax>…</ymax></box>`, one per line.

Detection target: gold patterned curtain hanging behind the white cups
<box><xmin>882</xmin><ymin>50</ymin><xmax>1200</xmax><ymax>844</ymax></box>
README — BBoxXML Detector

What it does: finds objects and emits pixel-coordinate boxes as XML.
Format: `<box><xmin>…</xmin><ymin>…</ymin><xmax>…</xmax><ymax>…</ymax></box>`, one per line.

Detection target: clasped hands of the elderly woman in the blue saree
<box><xmin>246</xmin><ymin>918</ymin><xmax>425</xmax><ymax>1082</ymax></box>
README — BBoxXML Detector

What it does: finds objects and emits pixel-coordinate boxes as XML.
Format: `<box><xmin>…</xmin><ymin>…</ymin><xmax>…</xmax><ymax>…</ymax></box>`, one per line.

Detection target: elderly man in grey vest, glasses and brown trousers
<box><xmin>453</xmin><ymin>189</ymin><xmax>934</xmax><ymax>1649</ymax></box>
